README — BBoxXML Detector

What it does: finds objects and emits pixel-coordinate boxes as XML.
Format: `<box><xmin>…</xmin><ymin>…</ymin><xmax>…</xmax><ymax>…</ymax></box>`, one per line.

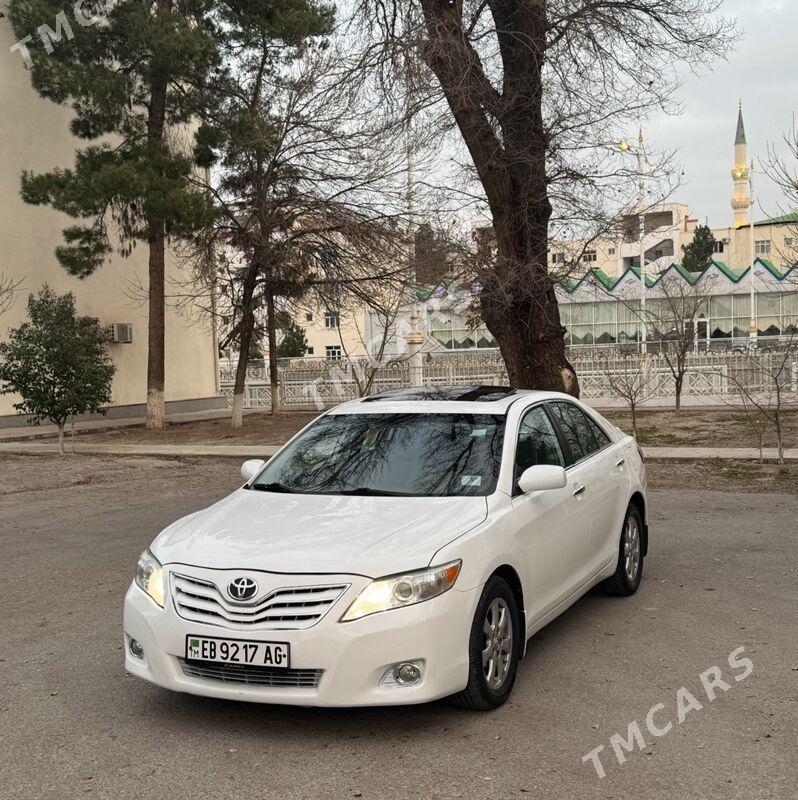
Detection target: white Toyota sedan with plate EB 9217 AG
<box><xmin>124</xmin><ymin>386</ymin><xmax>648</xmax><ymax>709</ymax></box>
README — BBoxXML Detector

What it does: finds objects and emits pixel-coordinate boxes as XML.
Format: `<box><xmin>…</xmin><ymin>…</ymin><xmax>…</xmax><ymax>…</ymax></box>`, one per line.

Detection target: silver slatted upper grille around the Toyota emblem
<box><xmin>170</xmin><ymin>573</ymin><xmax>349</xmax><ymax>630</ymax></box>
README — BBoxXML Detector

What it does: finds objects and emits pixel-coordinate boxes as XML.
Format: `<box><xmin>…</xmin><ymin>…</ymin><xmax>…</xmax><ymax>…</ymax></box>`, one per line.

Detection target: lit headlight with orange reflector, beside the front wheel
<box><xmin>339</xmin><ymin>560</ymin><xmax>463</xmax><ymax>622</ymax></box>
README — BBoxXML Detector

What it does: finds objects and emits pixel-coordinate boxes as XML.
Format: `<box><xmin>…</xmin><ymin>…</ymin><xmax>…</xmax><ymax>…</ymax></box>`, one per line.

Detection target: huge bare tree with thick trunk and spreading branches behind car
<box><xmin>356</xmin><ymin>0</ymin><xmax>734</xmax><ymax>394</ymax></box>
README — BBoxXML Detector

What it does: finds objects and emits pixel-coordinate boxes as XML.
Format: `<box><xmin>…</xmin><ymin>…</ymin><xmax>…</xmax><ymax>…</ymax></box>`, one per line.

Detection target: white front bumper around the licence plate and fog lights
<box><xmin>124</xmin><ymin>576</ymin><xmax>482</xmax><ymax>706</ymax></box>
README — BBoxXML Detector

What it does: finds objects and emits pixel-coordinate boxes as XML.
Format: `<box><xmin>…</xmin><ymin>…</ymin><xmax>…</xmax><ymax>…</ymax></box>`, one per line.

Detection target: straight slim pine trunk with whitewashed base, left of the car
<box><xmin>146</xmin><ymin>6</ymin><xmax>172</xmax><ymax>431</ymax></box>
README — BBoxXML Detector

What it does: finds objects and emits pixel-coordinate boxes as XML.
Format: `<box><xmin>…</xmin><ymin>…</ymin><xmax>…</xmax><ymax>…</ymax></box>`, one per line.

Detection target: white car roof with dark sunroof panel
<box><xmin>328</xmin><ymin>386</ymin><xmax>580</xmax><ymax>415</ymax></box>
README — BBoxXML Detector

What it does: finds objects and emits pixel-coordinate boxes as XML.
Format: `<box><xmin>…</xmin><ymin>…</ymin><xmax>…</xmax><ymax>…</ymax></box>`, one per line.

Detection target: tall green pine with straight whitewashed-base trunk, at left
<box><xmin>9</xmin><ymin>0</ymin><xmax>327</xmax><ymax>429</ymax></box>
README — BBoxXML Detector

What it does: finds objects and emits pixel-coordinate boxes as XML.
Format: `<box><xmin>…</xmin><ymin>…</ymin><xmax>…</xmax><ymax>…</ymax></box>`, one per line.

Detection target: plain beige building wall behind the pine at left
<box><xmin>0</xmin><ymin>18</ymin><xmax>224</xmax><ymax>426</ymax></box>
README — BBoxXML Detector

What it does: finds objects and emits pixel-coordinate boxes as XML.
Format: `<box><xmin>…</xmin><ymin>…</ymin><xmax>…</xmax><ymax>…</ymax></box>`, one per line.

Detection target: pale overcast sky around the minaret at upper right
<box><xmin>652</xmin><ymin>0</ymin><xmax>798</xmax><ymax>227</ymax></box>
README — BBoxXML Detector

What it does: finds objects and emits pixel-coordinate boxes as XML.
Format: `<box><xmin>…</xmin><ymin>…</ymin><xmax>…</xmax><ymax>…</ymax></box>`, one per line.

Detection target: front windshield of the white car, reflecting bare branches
<box><xmin>250</xmin><ymin>414</ymin><xmax>504</xmax><ymax>497</ymax></box>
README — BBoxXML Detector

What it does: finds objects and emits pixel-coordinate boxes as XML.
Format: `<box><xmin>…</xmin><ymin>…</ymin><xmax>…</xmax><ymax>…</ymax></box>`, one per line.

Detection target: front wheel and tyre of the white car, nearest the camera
<box><xmin>451</xmin><ymin>575</ymin><xmax>526</xmax><ymax>711</ymax></box>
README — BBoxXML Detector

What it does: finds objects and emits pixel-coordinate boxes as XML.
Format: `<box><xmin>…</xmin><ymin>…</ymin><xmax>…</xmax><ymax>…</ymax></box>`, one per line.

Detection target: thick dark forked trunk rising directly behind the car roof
<box><xmin>421</xmin><ymin>0</ymin><xmax>579</xmax><ymax>396</ymax></box>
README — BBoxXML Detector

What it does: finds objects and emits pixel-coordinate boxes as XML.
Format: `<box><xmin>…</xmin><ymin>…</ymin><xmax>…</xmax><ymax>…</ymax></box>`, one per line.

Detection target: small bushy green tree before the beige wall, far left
<box><xmin>0</xmin><ymin>286</ymin><xmax>116</xmax><ymax>455</ymax></box>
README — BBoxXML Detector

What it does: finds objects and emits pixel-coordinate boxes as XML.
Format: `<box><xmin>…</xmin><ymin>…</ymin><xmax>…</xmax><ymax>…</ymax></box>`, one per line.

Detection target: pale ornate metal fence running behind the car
<box><xmin>220</xmin><ymin>349</ymin><xmax>798</xmax><ymax>410</ymax></box>
